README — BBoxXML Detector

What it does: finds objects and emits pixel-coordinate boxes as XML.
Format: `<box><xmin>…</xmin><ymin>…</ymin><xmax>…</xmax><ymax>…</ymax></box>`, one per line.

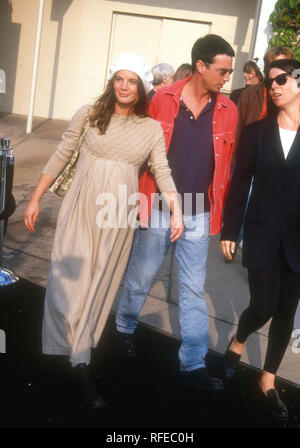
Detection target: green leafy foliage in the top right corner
<box><xmin>269</xmin><ymin>0</ymin><xmax>300</xmax><ymax>61</ymax></box>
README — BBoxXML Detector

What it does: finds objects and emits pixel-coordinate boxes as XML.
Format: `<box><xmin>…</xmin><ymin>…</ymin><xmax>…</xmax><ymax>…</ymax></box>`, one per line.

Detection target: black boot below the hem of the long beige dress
<box><xmin>74</xmin><ymin>364</ymin><xmax>106</xmax><ymax>409</ymax></box>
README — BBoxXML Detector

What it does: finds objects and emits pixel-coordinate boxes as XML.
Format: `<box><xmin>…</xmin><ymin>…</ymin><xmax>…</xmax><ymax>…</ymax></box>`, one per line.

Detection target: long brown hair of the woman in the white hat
<box><xmin>89</xmin><ymin>76</ymin><xmax>148</xmax><ymax>134</ymax></box>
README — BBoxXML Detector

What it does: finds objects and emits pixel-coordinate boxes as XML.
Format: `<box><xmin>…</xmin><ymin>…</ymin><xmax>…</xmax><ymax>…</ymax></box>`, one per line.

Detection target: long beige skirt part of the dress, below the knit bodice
<box><xmin>43</xmin><ymin>154</ymin><xmax>138</xmax><ymax>363</ymax></box>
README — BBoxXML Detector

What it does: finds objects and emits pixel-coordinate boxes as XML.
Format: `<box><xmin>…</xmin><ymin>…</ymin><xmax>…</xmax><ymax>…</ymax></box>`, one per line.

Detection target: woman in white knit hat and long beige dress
<box><xmin>24</xmin><ymin>53</ymin><xmax>183</xmax><ymax>409</ymax></box>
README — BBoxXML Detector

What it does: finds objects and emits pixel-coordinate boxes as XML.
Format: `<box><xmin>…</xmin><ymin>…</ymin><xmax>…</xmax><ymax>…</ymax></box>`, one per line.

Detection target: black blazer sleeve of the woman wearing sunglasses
<box><xmin>221</xmin><ymin>122</ymin><xmax>258</xmax><ymax>241</ymax></box>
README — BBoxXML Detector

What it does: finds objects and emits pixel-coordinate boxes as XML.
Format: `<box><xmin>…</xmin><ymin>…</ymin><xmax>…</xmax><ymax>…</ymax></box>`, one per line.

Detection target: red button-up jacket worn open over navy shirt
<box><xmin>139</xmin><ymin>77</ymin><xmax>237</xmax><ymax>235</ymax></box>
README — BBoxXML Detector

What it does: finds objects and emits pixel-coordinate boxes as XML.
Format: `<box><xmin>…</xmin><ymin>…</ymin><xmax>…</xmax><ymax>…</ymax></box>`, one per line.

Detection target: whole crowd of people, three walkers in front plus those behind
<box><xmin>24</xmin><ymin>34</ymin><xmax>300</xmax><ymax>418</ymax></box>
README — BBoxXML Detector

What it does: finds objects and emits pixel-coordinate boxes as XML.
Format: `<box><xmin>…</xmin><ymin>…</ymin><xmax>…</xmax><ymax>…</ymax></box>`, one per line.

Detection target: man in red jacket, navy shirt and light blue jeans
<box><xmin>117</xmin><ymin>34</ymin><xmax>237</xmax><ymax>390</ymax></box>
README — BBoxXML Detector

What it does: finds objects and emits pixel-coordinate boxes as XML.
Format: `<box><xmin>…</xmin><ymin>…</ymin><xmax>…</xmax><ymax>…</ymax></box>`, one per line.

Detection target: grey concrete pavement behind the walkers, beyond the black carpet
<box><xmin>0</xmin><ymin>113</ymin><xmax>300</xmax><ymax>387</ymax></box>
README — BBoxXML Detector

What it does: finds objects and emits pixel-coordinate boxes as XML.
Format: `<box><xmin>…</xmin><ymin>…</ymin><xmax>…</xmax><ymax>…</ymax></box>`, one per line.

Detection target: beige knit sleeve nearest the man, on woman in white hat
<box><xmin>148</xmin><ymin>120</ymin><xmax>177</xmax><ymax>193</ymax></box>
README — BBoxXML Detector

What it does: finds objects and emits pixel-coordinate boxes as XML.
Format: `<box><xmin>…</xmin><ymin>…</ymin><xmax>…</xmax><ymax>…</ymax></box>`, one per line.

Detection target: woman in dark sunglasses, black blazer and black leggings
<box><xmin>220</xmin><ymin>59</ymin><xmax>300</xmax><ymax>418</ymax></box>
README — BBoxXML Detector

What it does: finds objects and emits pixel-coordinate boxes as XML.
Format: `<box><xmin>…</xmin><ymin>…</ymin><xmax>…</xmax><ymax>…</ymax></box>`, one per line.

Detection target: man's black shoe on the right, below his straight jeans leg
<box><xmin>178</xmin><ymin>367</ymin><xmax>224</xmax><ymax>391</ymax></box>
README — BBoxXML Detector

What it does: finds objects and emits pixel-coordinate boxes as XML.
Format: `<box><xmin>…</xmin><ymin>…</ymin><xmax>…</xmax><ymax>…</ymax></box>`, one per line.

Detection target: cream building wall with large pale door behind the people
<box><xmin>0</xmin><ymin>0</ymin><xmax>256</xmax><ymax>119</ymax></box>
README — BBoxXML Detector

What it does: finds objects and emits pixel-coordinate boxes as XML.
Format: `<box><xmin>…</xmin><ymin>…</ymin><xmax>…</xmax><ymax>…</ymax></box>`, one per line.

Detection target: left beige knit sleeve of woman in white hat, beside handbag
<box><xmin>42</xmin><ymin>105</ymin><xmax>89</xmax><ymax>179</ymax></box>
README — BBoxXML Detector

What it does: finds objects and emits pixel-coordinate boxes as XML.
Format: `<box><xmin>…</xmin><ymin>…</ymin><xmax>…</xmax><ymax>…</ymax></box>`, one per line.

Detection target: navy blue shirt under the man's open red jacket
<box><xmin>168</xmin><ymin>97</ymin><xmax>216</xmax><ymax>215</ymax></box>
